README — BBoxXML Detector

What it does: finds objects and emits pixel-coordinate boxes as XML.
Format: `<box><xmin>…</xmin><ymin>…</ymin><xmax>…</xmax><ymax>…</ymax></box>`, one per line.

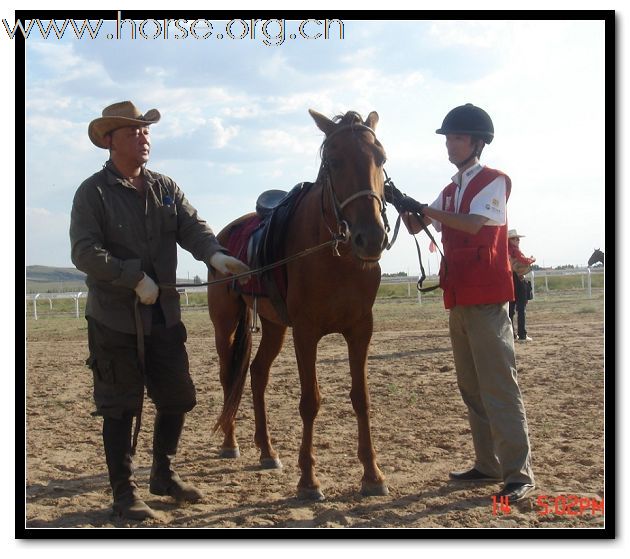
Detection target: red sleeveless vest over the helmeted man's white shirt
<box><xmin>440</xmin><ymin>167</ymin><xmax>514</xmax><ymax>309</ymax></box>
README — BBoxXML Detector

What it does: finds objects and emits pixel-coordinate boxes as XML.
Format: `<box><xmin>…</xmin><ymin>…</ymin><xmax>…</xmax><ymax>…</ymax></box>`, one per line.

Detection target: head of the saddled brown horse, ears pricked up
<box><xmin>309</xmin><ymin>109</ymin><xmax>387</xmax><ymax>262</ymax></box>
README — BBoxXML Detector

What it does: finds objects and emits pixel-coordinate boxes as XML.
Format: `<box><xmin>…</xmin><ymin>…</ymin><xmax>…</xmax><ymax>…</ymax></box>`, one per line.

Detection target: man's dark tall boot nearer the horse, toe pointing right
<box><xmin>149</xmin><ymin>412</ymin><xmax>203</xmax><ymax>503</ymax></box>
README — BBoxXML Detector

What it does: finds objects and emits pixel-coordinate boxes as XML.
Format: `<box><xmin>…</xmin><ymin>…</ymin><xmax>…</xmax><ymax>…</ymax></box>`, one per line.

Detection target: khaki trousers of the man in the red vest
<box><xmin>449</xmin><ymin>303</ymin><xmax>534</xmax><ymax>483</ymax></box>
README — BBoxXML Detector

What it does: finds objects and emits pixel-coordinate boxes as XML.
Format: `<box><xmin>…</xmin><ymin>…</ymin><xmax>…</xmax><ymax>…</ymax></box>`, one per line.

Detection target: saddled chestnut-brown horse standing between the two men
<box><xmin>208</xmin><ymin>110</ymin><xmax>388</xmax><ymax>500</ymax></box>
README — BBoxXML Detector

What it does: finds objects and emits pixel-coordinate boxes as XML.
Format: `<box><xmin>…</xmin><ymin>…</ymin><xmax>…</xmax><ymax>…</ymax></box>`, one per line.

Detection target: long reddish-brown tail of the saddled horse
<box><xmin>213</xmin><ymin>299</ymin><xmax>252</xmax><ymax>431</ymax></box>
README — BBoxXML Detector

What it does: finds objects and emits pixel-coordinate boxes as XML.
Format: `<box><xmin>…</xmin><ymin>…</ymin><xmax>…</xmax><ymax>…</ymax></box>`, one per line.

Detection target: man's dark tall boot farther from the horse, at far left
<box><xmin>103</xmin><ymin>415</ymin><xmax>156</xmax><ymax>520</ymax></box>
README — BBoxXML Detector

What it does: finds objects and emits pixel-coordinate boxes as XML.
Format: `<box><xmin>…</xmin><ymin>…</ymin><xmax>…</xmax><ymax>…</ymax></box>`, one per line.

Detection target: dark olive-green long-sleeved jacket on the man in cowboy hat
<box><xmin>70</xmin><ymin>161</ymin><xmax>226</xmax><ymax>334</ymax></box>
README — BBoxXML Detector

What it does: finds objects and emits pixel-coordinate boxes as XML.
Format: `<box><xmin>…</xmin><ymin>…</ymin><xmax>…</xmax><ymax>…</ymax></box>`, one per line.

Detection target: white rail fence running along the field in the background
<box><xmin>24</xmin><ymin>266</ymin><xmax>605</xmax><ymax>320</ymax></box>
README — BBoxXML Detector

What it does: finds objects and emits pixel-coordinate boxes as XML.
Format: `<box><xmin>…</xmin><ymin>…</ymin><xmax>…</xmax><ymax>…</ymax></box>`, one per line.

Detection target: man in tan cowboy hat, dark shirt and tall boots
<box><xmin>70</xmin><ymin>101</ymin><xmax>248</xmax><ymax>520</ymax></box>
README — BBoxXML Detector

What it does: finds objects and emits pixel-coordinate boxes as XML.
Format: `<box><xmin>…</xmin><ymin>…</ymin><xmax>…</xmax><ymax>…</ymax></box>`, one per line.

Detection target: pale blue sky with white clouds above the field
<box><xmin>26</xmin><ymin>13</ymin><xmax>612</xmax><ymax>277</ymax></box>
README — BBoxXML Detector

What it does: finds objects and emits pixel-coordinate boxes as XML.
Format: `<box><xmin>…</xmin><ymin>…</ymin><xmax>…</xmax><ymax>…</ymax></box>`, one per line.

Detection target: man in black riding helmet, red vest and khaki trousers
<box><xmin>405</xmin><ymin>103</ymin><xmax>534</xmax><ymax>502</ymax></box>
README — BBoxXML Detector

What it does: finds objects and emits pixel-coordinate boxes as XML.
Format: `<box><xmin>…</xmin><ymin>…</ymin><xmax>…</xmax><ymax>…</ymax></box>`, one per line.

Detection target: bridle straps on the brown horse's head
<box><xmin>320</xmin><ymin>123</ymin><xmax>389</xmax><ymax>254</ymax></box>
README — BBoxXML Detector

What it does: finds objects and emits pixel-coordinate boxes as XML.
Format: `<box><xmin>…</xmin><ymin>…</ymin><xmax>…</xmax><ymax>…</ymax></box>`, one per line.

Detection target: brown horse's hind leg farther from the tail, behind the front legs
<box><xmin>250</xmin><ymin>317</ymin><xmax>287</xmax><ymax>469</ymax></box>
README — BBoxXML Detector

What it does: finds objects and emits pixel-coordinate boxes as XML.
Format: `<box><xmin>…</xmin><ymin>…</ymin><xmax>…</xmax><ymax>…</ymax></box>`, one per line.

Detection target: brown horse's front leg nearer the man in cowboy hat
<box><xmin>293</xmin><ymin>325</ymin><xmax>324</xmax><ymax>501</ymax></box>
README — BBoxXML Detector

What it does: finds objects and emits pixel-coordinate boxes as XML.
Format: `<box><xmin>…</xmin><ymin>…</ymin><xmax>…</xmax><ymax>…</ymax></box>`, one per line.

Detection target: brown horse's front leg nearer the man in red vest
<box><xmin>343</xmin><ymin>312</ymin><xmax>389</xmax><ymax>496</ymax></box>
